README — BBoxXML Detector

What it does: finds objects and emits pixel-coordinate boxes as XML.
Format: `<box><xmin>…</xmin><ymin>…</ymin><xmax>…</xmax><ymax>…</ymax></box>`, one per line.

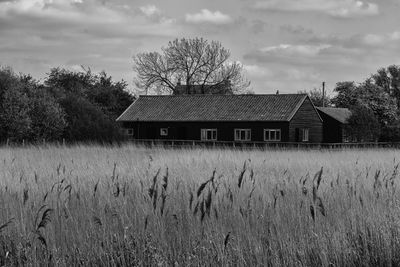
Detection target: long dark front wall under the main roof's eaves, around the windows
<box><xmin>123</xmin><ymin>122</ymin><xmax>289</xmax><ymax>142</ymax></box>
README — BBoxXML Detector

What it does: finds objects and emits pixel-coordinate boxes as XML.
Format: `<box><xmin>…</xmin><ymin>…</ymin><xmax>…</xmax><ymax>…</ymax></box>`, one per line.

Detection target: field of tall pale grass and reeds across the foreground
<box><xmin>0</xmin><ymin>145</ymin><xmax>400</xmax><ymax>266</ymax></box>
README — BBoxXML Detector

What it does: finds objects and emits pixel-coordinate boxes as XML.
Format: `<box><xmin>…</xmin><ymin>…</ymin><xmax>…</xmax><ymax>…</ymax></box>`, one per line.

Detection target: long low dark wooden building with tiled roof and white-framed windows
<box><xmin>117</xmin><ymin>94</ymin><xmax>323</xmax><ymax>143</ymax></box>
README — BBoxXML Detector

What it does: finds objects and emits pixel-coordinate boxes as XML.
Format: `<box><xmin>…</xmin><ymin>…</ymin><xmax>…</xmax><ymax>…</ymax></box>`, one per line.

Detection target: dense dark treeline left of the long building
<box><xmin>0</xmin><ymin>67</ymin><xmax>134</xmax><ymax>142</ymax></box>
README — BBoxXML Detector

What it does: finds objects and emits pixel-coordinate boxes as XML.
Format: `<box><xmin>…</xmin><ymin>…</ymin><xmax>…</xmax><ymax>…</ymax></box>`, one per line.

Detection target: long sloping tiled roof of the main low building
<box><xmin>117</xmin><ymin>94</ymin><xmax>307</xmax><ymax>121</ymax></box>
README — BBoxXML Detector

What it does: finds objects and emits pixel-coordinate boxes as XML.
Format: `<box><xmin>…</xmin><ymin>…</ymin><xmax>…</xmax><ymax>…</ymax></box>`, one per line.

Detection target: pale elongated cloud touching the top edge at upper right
<box><xmin>253</xmin><ymin>0</ymin><xmax>379</xmax><ymax>17</ymax></box>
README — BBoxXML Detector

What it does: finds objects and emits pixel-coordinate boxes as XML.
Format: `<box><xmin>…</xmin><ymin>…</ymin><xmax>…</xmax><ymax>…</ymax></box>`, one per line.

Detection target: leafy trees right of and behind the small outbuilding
<box><xmin>308</xmin><ymin>65</ymin><xmax>400</xmax><ymax>142</ymax></box>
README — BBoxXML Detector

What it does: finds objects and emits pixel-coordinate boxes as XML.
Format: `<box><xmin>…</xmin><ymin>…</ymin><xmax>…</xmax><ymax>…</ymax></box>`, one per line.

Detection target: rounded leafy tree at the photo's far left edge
<box><xmin>0</xmin><ymin>68</ymin><xmax>66</xmax><ymax>141</ymax></box>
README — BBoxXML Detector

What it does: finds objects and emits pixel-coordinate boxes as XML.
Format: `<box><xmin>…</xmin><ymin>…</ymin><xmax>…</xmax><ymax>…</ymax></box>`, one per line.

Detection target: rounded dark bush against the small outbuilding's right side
<box><xmin>347</xmin><ymin>105</ymin><xmax>380</xmax><ymax>142</ymax></box>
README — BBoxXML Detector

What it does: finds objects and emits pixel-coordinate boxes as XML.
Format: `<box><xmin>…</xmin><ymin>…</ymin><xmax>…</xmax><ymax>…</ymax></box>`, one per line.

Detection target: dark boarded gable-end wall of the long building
<box><xmin>289</xmin><ymin>97</ymin><xmax>323</xmax><ymax>143</ymax></box>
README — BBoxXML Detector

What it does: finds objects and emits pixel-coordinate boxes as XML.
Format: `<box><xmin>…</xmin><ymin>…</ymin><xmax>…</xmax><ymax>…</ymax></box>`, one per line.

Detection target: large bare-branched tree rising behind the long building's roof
<box><xmin>133</xmin><ymin>38</ymin><xmax>250</xmax><ymax>94</ymax></box>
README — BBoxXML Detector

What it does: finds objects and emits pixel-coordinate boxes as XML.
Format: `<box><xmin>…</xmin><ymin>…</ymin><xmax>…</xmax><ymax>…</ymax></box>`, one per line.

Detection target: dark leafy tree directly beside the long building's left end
<box><xmin>45</xmin><ymin>68</ymin><xmax>134</xmax><ymax>142</ymax></box>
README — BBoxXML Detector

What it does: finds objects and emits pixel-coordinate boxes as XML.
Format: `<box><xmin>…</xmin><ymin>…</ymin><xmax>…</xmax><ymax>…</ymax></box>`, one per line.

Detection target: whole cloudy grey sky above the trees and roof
<box><xmin>0</xmin><ymin>0</ymin><xmax>400</xmax><ymax>94</ymax></box>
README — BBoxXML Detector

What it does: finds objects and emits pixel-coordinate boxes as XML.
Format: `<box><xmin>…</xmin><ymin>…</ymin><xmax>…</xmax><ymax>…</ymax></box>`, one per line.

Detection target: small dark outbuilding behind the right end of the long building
<box><xmin>317</xmin><ymin>107</ymin><xmax>351</xmax><ymax>143</ymax></box>
